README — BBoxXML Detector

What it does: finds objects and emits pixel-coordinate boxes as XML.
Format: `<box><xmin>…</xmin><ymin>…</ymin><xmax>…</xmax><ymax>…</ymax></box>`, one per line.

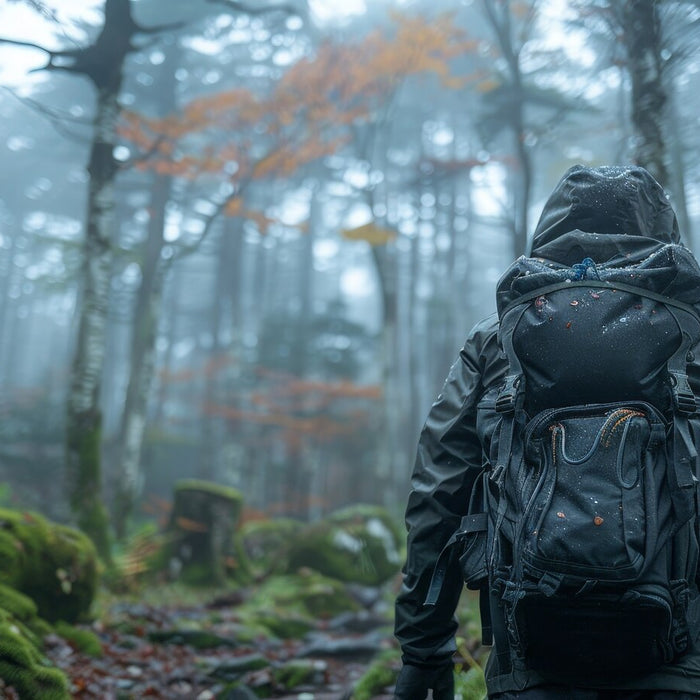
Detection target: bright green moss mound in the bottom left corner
<box><xmin>0</xmin><ymin>611</ymin><xmax>70</xmax><ymax>700</ymax></box>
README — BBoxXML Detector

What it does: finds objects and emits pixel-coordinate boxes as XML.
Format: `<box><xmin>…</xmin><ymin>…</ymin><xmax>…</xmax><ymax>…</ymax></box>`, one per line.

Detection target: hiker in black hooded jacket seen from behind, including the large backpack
<box><xmin>395</xmin><ymin>166</ymin><xmax>700</xmax><ymax>700</ymax></box>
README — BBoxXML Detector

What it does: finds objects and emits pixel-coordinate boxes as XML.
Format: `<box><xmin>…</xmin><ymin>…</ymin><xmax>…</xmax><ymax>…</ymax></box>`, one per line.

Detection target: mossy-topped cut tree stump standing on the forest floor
<box><xmin>168</xmin><ymin>480</ymin><xmax>243</xmax><ymax>585</ymax></box>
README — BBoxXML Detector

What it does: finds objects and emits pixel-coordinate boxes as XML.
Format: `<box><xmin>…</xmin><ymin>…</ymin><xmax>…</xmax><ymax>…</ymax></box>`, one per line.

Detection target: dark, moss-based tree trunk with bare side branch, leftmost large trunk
<box><xmin>65</xmin><ymin>0</ymin><xmax>143</xmax><ymax>561</ymax></box>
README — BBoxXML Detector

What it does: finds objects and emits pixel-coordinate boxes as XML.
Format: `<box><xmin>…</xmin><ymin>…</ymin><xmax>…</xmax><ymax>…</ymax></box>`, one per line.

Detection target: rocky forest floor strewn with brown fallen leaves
<box><xmin>30</xmin><ymin>591</ymin><xmax>398</xmax><ymax>700</ymax></box>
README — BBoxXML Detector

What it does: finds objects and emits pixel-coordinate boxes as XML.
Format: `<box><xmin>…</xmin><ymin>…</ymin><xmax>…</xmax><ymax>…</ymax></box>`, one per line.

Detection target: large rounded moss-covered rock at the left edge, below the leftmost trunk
<box><xmin>0</xmin><ymin>509</ymin><xmax>97</xmax><ymax>622</ymax></box>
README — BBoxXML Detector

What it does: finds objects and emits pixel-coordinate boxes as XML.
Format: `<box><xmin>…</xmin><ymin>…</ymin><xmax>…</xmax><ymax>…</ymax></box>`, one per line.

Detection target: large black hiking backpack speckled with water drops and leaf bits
<box><xmin>426</xmin><ymin>244</ymin><xmax>700</xmax><ymax>685</ymax></box>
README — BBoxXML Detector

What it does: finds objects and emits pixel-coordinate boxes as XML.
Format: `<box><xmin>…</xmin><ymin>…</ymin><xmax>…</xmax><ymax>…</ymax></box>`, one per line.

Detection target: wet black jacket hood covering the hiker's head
<box><xmin>529</xmin><ymin>165</ymin><xmax>680</xmax><ymax>264</ymax></box>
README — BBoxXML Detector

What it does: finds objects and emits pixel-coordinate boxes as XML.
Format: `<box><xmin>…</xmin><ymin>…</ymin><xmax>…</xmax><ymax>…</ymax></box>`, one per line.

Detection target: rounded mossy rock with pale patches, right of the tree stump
<box><xmin>289</xmin><ymin>505</ymin><xmax>402</xmax><ymax>586</ymax></box>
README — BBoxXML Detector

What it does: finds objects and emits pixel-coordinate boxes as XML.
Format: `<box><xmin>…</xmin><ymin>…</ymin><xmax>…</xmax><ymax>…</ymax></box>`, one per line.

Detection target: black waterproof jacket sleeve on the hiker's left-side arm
<box><xmin>395</xmin><ymin>318</ymin><xmax>495</xmax><ymax>665</ymax></box>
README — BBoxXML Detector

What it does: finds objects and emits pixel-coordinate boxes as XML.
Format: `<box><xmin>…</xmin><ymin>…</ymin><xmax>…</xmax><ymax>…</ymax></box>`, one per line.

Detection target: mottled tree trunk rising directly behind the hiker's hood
<box><xmin>622</xmin><ymin>0</ymin><xmax>668</xmax><ymax>187</ymax></box>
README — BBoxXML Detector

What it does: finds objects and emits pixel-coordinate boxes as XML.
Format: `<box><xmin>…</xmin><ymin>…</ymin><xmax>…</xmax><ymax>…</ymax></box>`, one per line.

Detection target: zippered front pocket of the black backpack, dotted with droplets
<box><xmin>521</xmin><ymin>404</ymin><xmax>664</xmax><ymax>582</ymax></box>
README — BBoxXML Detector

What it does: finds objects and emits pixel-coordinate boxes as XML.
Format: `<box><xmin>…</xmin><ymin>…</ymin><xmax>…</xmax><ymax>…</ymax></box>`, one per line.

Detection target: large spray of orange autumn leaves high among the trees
<box><xmin>120</xmin><ymin>13</ymin><xmax>476</xmax><ymax>198</ymax></box>
